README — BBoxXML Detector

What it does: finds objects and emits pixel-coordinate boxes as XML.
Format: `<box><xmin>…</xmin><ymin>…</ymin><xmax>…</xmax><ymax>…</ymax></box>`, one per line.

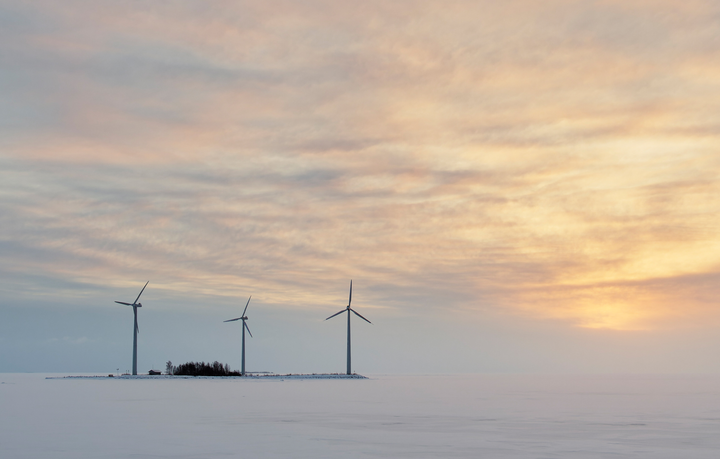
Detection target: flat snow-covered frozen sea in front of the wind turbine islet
<box><xmin>0</xmin><ymin>373</ymin><xmax>720</xmax><ymax>459</ymax></box>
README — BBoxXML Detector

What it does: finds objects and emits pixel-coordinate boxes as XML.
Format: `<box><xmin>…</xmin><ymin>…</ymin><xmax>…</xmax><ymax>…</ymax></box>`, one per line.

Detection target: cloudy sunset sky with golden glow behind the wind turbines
<box><xmin>0</xmin><ymin>0</ymin><xmax>720</xmax><ymax>373</ymax></box>
